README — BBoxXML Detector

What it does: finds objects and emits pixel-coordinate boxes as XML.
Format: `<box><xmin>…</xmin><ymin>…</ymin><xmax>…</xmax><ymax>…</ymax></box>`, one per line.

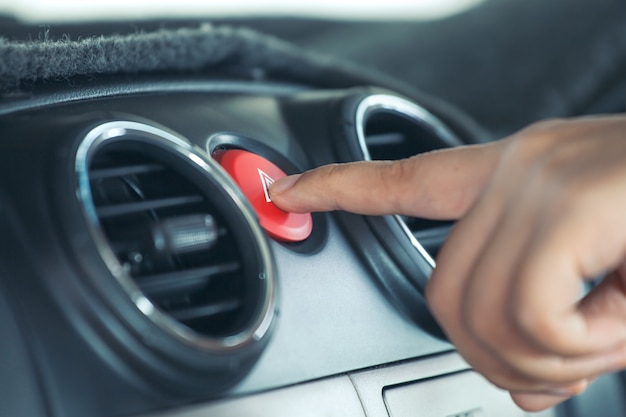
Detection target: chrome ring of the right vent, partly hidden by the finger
<box><xmin>355</xmin><ymin>94</ymin><xmax>458</xmax><ymax>268</ymax></box>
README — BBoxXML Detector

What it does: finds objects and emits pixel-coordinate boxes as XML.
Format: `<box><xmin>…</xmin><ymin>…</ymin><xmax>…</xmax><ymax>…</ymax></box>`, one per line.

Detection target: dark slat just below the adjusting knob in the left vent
<box><xmin>135</xmin><ymin>262</ymin><xmax>241</xmax><ymax>296</ymax></box>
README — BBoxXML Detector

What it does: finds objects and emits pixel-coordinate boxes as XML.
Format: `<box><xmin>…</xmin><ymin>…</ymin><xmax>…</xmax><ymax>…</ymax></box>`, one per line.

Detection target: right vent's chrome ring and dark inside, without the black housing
<box><xmin>356</xmin><ymin>94</ymin><xmax>460</xmax><ymax>265</ymax></box>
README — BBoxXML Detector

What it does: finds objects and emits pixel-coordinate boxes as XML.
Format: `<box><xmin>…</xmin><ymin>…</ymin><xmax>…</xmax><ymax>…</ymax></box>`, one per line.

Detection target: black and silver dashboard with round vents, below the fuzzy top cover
<box><xmin>0</xmin><ymin>6</ymin><xmax>626</xmax><ymax>417</ymax></box>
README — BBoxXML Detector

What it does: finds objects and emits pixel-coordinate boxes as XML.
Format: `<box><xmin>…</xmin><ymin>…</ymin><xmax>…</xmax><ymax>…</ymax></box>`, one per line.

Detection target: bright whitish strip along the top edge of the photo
<box><xmin>0</xmin><ymin>0</ymin><xmax>482</xmax><ymax>21</ymax></box>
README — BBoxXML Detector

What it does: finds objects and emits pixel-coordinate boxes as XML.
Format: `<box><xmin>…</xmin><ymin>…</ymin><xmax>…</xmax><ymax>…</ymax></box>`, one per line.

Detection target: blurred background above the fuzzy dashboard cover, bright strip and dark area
<box><xmin>0</xmin><ymin>0</ymin><xmax>626</xmax><ymax>137</ymax></box>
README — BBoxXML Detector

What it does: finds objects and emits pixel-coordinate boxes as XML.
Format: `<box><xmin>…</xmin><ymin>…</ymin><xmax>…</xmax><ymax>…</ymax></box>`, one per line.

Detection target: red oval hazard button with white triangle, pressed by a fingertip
<box><xmin>214</xmin><ymin>149</ymin><xmax>313</xmax><ymax>242</ymax></box>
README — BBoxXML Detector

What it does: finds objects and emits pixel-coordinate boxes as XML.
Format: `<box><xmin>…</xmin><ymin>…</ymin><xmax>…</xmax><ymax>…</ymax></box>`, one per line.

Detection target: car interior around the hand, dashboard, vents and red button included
<box><xmin>0</xmin><ymin>0</ymin><xmax>626</xmax><ymax>417</ymax></box>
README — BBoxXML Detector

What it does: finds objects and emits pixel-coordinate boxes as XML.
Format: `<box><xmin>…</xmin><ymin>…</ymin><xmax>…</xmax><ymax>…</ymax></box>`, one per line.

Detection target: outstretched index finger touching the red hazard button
<box><xmin>269</xmin><ymin>142</ymin><xmax>502</xmax><ymax>219</ymax></box>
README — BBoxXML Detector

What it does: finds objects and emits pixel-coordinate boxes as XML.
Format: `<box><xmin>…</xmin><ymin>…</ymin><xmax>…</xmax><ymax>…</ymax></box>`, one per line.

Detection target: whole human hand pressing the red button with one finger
<box><xmin>270</xmin><ymin>117</ymin><xmax>626</xmax><ymax>411</ymax></box>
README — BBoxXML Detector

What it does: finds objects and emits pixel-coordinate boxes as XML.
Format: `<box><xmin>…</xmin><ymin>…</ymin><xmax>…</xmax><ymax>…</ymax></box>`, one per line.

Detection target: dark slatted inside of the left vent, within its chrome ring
<box><xmin>83</xmin><ymin>139</ymin><xmax>264</xmax><ymax>340</ymax></box>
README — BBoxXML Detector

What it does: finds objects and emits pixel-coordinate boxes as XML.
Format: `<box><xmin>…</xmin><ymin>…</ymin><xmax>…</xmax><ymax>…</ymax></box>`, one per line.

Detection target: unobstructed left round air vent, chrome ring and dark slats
<box><xmin>77</xmin><ymin>122</ymin><xmax>274</xmax><ymax>351</ymax></box>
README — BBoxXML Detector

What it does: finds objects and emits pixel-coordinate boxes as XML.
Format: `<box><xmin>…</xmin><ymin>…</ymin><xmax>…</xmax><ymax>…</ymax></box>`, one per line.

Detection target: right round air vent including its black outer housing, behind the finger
<box><xmin>336</xmin><ymin>90</ymin><xmax>461</xmax><ymax>337</ymax></box>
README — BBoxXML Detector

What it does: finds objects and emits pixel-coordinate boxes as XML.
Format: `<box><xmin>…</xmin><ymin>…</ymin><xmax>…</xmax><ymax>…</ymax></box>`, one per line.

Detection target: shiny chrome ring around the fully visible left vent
<box><xmin>75</xmin><ymin>121</ymin><xmax>276</xmax><ymax>352</ymax></box>
